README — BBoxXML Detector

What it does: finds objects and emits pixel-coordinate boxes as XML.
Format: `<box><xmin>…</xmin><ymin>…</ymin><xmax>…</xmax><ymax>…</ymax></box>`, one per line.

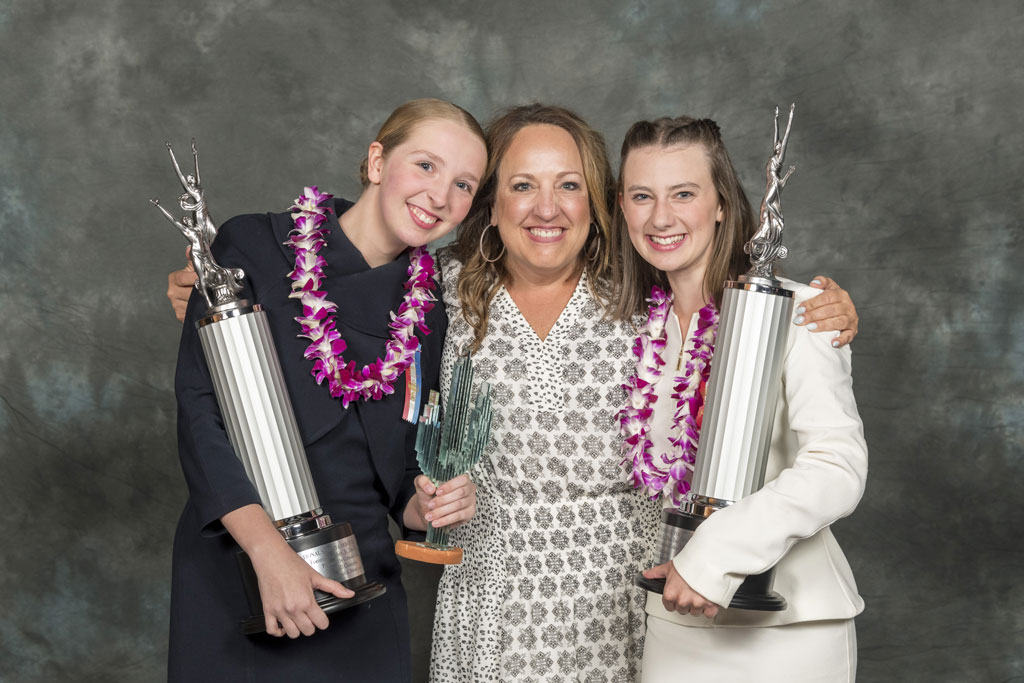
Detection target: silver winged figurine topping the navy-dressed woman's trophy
<box><xmin>150</xmin><ymin>139</ymin><xmax>246</xmax><ymax>308</ymax></box>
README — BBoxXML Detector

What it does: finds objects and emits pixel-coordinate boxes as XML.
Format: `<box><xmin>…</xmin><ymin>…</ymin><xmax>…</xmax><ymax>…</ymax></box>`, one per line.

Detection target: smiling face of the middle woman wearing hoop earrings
<box><xmin>490</xmin><ymin>124</ymin><xmax>591</xmax><ymax>280</ymax></box>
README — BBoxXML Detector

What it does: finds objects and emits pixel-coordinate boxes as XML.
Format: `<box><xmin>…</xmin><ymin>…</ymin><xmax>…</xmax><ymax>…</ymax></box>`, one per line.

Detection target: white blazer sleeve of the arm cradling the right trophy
<box><xmin>674</xmin><ymin>287</ymin><xmax>867</xmax><ymax>605</ymax></box>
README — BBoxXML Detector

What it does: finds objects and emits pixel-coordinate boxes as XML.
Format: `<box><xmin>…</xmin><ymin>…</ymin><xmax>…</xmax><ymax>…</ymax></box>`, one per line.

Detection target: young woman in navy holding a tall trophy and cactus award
<box><xmin>168</xmin><ymin>99</ymin><xmax>486</xmax><ymax>683</ymax></box>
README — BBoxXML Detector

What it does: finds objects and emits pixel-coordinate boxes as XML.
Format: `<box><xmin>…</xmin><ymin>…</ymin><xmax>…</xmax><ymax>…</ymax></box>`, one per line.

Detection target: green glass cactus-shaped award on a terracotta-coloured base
<box><xmin>394</xmin><ymin>353</ymin><xmax>490</xmax><ymax>564</ymax></box>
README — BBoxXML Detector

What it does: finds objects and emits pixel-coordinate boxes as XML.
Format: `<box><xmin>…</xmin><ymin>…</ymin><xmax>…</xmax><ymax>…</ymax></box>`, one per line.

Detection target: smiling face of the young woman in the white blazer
<box><xmin>618</xmin><ymin>143</ymin><xmax>723</xmax><ymax>283</ymax></box>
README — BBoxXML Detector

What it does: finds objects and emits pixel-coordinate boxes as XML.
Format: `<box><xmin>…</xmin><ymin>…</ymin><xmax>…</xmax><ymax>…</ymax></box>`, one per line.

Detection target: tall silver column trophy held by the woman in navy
<box><xmin>151</xmin><ymin>140</ymin><xmax>386</xmax><ymax>635</ymax></box>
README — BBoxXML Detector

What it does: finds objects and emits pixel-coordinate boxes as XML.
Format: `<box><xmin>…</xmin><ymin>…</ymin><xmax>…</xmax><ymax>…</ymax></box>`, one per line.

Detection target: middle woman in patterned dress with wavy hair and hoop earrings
<box><xmin>423</xmin><ymin>104</ymin><xmax>854</xmax><ymax>683</ymax></box>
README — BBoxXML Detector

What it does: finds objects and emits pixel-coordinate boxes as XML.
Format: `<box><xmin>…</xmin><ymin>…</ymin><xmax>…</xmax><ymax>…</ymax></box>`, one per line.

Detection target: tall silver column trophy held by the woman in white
<box><xmin>636</xmin><ymin>105</ymin><xmax>796</xmax><ymax>611</ymax></box>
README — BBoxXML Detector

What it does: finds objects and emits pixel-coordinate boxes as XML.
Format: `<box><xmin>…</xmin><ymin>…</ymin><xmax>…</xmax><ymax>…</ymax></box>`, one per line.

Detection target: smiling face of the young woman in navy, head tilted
<box><xmin>367</xmin><ymin>119</ymin><xmax>487</xmax><ymax>253</ymax></box>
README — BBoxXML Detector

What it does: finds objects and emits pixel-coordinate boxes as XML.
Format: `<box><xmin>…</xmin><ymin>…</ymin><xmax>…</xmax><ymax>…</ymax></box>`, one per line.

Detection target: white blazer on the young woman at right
<box><xmin>647</xmin><ymin>281</ymin><xmax>867</xmax><ymax>626</ymax></box>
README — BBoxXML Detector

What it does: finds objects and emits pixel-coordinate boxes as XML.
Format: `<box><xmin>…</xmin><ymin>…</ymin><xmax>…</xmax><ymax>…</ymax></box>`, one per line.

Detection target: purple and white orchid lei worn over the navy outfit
<box><xmin>285</xmin><ymin>185</ymin><xmax>435</xmax><ymax>408</ymax></box>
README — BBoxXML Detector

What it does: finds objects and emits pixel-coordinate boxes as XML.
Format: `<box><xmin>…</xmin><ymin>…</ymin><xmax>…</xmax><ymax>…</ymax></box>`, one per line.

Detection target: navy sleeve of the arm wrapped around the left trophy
<box><xmin>174</xmin><ymin>216</ymin><xmax>276</xmax><ymax>536</ymax></box>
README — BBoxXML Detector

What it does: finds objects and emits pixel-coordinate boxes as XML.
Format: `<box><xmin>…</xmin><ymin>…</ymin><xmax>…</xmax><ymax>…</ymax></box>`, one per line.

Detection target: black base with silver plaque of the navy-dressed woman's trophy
<box><xmin>236</xmin><ymin>522</ymin><xmax>387</xmax><ymax>636</ymax></box>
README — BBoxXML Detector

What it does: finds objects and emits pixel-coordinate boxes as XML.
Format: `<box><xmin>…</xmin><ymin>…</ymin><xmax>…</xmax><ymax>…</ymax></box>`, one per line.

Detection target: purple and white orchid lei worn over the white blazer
<box><xmin>617</xmin><ymin>286</ymin><xmax>718</xmax><ymax>505</ymax></box>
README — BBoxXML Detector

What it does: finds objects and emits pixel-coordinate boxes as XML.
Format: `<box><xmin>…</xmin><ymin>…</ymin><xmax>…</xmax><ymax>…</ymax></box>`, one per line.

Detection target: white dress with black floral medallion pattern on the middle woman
<box><xmin>430</xmin><ymin>250</ymin><xmax>660</xmax><ymax>683</ymax></box>
